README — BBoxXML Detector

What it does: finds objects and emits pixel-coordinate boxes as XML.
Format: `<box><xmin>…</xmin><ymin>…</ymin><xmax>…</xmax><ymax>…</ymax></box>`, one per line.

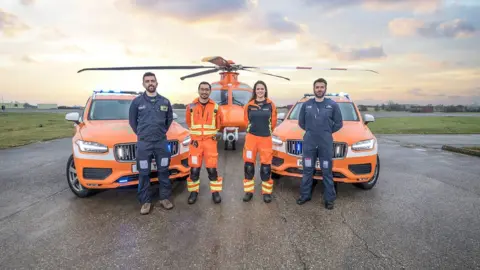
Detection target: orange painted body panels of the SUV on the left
<box><xmin>72</xmin><ymin>95</ymin><xmax>190</xmax><ymax>189</ymax></box>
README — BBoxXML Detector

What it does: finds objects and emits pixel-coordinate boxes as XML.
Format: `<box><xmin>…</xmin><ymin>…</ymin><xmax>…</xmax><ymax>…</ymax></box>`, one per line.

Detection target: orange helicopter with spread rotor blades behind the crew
<box><xmin>77</xmin><ymin>56</ymin><xmax>378</xmax><ymax>150</ymax></box>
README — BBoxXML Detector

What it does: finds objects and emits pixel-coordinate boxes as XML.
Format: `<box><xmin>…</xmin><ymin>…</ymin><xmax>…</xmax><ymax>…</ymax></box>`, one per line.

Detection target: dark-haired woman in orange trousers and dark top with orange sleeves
<box><xmin>243</xmin><ymin>81</ymin><xmax>277</xmax><ymax>203</ymax></box>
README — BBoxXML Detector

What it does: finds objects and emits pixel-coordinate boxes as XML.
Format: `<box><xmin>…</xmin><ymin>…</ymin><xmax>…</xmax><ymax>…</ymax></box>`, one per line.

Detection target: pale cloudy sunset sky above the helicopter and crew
<box><xmin>0</xmin><ymin>0</ymin><xmax>480</xmax><ymax>105</ymax></box>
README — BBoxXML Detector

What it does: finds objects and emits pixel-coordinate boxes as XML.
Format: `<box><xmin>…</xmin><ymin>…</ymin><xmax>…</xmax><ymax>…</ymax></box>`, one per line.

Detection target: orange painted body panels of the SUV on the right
<box><xmin>272</xmin><ymin>96</ymin><xmax>379</xmax><ymax>184</ymax></box>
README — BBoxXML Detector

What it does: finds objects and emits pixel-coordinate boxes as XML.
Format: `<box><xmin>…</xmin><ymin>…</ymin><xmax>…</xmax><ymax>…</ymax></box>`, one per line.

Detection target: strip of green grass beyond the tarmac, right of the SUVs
<box><xmin>368</xmin><ymin>116</ymin><xmax>480</xmax><ymax>134</ymax></box>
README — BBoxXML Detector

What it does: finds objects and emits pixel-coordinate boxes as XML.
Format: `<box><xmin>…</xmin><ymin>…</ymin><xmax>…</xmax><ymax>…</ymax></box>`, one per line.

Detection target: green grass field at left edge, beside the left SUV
<box><xmin>0</xmin><ymin>113</ymin><xmax>74</xmax><ymax>149</ymax></box>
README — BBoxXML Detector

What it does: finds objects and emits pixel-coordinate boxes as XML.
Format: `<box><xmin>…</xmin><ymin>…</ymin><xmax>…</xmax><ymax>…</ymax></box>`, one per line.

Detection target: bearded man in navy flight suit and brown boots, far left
<box><xmin>129</xmin><ymin>72</ymin><xmax>173</xmax><ymax>215</ymax></box>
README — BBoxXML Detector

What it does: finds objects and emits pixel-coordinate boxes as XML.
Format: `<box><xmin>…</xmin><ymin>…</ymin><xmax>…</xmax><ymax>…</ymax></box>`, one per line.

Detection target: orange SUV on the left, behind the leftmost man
<box><xmin>65</xmin><ymin>90</ymin><xmax>190</xmax><ymax>198</ymax></box>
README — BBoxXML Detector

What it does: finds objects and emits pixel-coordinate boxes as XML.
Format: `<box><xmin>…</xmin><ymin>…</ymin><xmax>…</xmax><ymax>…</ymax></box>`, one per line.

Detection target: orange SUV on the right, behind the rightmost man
<box><xmin>272</xmin><ymin>93</ymin><xmax>380</xmax><ymax>189</ymax></box>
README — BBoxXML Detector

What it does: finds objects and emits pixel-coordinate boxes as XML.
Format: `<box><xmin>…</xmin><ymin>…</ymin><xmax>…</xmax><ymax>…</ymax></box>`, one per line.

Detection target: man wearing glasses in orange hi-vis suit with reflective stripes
<box><xmin>185</xmin><ymin>82</ymin><xmax>223</xmax><ymax>204</ymax></box>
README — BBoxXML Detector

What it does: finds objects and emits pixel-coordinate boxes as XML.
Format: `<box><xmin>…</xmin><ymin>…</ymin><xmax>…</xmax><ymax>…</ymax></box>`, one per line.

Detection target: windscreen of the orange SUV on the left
<box><xmin>88</xmin><ymin>99</ymin><xmax>132</xmax><ymax>120</ymax></box>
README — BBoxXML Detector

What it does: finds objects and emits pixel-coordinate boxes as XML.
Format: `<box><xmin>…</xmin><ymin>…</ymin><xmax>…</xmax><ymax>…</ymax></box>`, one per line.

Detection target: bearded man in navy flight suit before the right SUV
<box><xmin>297</xmin><ymin>78</ymin><xmax>343</xmax><ymax>209</ymax></box>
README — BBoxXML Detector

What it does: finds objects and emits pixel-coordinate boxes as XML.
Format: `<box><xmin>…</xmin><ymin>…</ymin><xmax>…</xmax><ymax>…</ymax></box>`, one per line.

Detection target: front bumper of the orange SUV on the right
<box><xmin>272</xmin><ymin>141</ymin><xmax>377</xmax><ymax>184</ymax></box>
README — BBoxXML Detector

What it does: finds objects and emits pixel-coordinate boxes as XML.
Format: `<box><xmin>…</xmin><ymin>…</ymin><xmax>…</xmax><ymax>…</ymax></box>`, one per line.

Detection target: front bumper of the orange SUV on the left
<box><xmin>74</xmin><ymin>145</ymin><xmax>190</xmax><ymax>189</ymax></box>
